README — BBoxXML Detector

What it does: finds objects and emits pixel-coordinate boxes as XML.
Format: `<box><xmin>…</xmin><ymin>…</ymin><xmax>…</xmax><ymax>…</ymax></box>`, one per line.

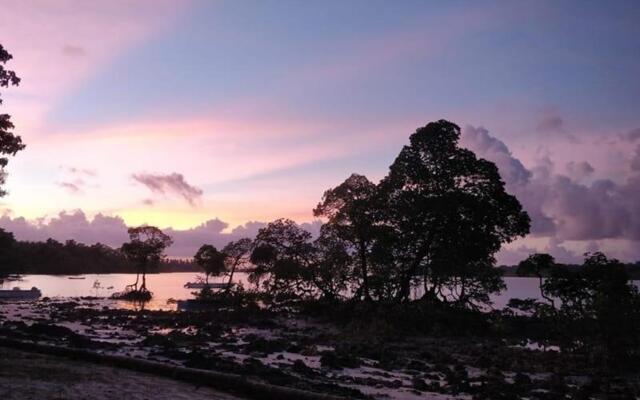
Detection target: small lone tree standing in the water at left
<box><xmin>121</xmin><ymin>226</ymin><xmax>173</xmax><ymax>299</ymax></box>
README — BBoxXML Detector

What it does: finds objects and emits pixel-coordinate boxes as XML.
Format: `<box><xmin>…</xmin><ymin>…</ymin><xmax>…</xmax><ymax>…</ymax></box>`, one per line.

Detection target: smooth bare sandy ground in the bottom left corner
<box><xmin>0</xmin><ymin>347</ymin><xmax>239</xmax><ymax>400</ymax></box>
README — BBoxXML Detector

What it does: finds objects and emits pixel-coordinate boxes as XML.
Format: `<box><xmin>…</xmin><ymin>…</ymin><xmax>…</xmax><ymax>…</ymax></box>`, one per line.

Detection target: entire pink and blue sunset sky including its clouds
<box><xmin>0</xmin><ymin>0</ymin><xmax>640</xmax><ymax>263</ymax></box>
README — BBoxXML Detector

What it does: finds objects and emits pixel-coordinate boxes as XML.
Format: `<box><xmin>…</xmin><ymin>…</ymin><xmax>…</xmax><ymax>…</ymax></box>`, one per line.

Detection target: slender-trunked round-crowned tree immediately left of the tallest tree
<box><xmin>313</xmin><ymin>174</ymin><xmax>378</xmax><ymax>300</ymax></box>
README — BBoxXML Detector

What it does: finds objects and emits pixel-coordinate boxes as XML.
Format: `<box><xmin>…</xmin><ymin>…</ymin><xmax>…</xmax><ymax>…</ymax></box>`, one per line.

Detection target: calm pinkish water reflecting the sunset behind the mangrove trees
<box><xmin>2</xmin><ymin>272</ymin><xmax>552</xmax><ymax>309</ymax></box>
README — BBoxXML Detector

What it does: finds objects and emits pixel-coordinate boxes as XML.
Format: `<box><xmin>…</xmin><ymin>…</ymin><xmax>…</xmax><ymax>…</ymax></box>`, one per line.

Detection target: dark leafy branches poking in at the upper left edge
<box><xmin>0</xmin><ymin>44</ymin><xmax>25</xmax><ymax>197</ymax></box>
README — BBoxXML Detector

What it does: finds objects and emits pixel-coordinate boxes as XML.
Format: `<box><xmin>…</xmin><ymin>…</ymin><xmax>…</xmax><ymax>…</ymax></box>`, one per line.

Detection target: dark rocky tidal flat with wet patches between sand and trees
<box><xmin>0</xmin><ymin>298</ymin><xmax>640</xmax><ymax>399</ymax></box>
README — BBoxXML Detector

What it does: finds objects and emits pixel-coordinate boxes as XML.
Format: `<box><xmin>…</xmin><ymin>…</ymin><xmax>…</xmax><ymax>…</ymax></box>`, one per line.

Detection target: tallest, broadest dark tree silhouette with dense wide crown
<box><xmin>379</xmin><ymin>120</ymin><xmax>530</xmax><ymax>302</ymax></box>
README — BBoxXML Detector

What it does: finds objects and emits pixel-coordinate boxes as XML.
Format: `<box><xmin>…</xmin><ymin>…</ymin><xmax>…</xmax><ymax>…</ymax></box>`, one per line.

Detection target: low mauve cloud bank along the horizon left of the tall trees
<box><xmin>0</xmin><ymin>210</ymin><xmax>322</xmax><ymax>257</ymax></box>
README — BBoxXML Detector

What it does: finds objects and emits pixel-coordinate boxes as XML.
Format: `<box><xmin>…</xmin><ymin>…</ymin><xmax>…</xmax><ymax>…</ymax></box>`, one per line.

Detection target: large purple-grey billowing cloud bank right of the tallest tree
<box><xmin>461</xmin><ymin>127</ymin><xmax>640</xmax><ymax>241</ymax></box>
